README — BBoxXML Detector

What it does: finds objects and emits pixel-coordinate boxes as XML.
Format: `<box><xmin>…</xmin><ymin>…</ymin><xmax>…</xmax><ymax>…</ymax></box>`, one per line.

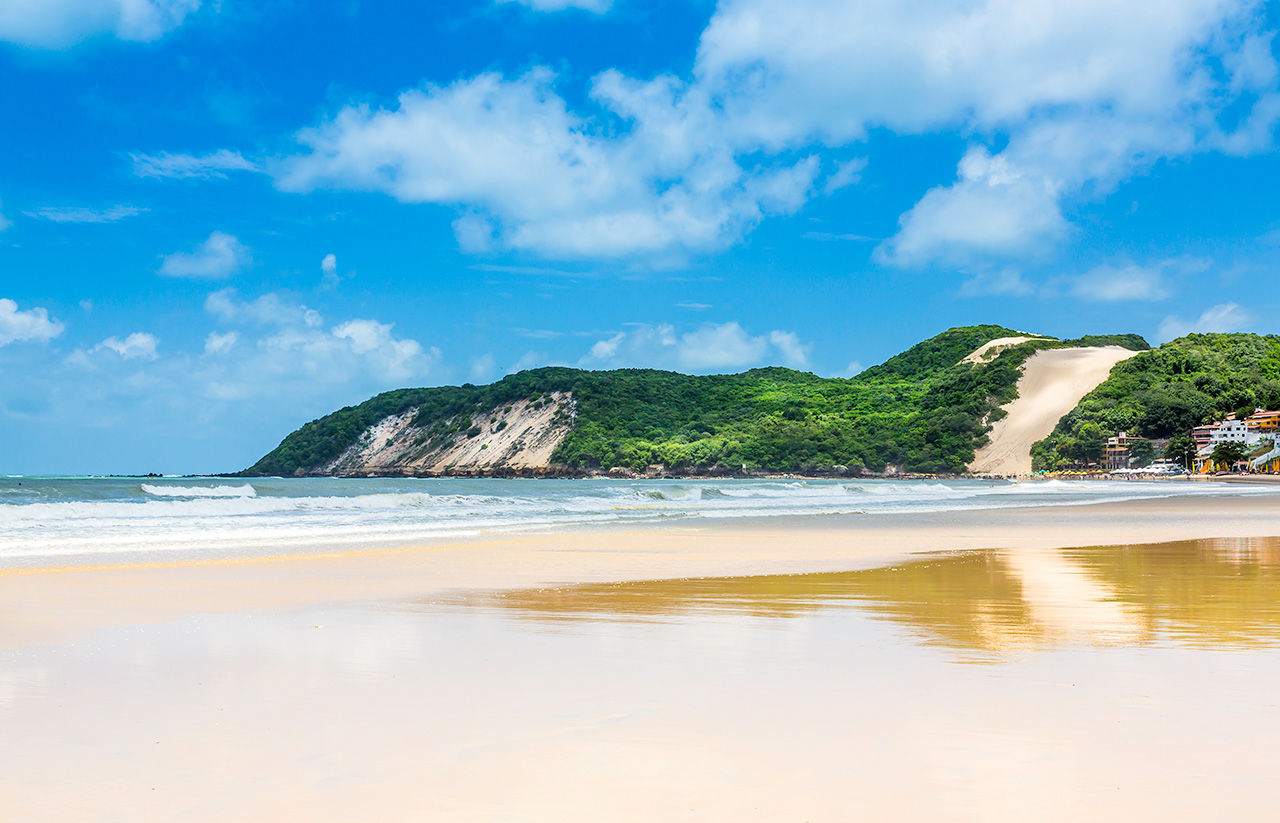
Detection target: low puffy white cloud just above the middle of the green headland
<box><xmin>579</xmin><ymin>321</ymin><xmax>813</xmax><ymax>371</ymax></box>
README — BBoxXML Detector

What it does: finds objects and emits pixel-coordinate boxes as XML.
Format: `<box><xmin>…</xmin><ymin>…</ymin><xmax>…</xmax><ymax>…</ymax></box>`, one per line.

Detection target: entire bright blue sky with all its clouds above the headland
<box><xmin>0</xmin><ymin>0</ymin><xmax>1280</xmax><ymax>474</ymax></box>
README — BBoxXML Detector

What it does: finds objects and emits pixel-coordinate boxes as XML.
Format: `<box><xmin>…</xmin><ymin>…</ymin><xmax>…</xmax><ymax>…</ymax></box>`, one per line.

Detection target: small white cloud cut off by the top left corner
<box><xmin>0</xmin><ymin>0</ymin><xmax>200</xmax><ymax>49</ymax></box>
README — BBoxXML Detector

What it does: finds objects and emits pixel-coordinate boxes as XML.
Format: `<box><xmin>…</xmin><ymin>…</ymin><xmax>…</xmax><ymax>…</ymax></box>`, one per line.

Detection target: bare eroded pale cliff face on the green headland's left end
<box><xmin>317</xmin><ymin>392</ymin><xmax>576</xmax><ymax>477</ymax></box>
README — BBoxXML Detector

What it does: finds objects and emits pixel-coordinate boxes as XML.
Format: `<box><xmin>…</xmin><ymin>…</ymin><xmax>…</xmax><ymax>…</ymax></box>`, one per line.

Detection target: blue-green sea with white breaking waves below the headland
<box><xmin>0</xmin><ymin>476</ymin><xmax>1280</xmax><ymax>567</ymax></box>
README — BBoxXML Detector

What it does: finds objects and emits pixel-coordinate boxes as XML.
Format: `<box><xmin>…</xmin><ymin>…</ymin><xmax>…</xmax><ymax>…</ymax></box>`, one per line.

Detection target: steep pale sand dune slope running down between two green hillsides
<box><xmin>969</xmin><ymin>346</ymin><xmax>1138</xmax><ymax>475</ymax></box>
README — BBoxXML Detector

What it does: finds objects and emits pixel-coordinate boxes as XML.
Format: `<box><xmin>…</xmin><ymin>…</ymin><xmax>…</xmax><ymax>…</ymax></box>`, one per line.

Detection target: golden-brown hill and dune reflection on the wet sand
<box><xmin>453</xmin><ymin>538</ymin><xmax>1280</xmax><ymax>651</ymax></box>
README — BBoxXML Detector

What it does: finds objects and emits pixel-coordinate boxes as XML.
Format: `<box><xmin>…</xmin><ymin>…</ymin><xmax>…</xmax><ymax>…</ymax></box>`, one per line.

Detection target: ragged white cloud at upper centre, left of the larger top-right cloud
<box><xmin>273</xmin><ymin>69</ymin><xmax>819</xmax><ymax>257</ymax></box>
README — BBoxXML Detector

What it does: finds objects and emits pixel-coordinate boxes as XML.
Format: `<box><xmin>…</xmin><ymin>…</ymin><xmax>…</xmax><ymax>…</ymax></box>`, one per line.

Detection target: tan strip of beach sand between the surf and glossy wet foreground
<box><xmin>0</xmin><ymin>495</ymin><xmax>1280</xmax><ymax>649</ymax></box>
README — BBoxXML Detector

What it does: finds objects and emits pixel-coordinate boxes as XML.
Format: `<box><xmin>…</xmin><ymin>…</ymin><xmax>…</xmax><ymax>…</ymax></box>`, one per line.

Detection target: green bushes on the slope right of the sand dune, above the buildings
<box><xmin>1032</xmin><ymin>334</ymin><xmax>1280</xmax><ymax>468</ymax></box>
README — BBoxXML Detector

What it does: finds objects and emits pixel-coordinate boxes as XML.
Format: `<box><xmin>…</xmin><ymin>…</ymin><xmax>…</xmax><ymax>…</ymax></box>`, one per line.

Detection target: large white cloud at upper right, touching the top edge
<box><xmin>696</xmin><ymin>0</ymin><xmax>1280</xmax><ymax>266</ymax></box>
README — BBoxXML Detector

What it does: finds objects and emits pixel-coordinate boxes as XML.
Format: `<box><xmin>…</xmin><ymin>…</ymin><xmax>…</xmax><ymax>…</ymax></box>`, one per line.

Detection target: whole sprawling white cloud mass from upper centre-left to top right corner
<box><xmin>273</xmin><ymin>0</ymin><xmax>1280</xmax><ymax>268</ymax></box>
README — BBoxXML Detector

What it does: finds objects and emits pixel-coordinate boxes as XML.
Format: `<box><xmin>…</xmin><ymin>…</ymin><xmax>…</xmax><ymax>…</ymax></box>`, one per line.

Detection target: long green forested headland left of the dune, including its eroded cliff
<box><xmin>243</xmin><ymin>325</ymin><xmax>1148</xmax><ymax>475</ymax></box>
